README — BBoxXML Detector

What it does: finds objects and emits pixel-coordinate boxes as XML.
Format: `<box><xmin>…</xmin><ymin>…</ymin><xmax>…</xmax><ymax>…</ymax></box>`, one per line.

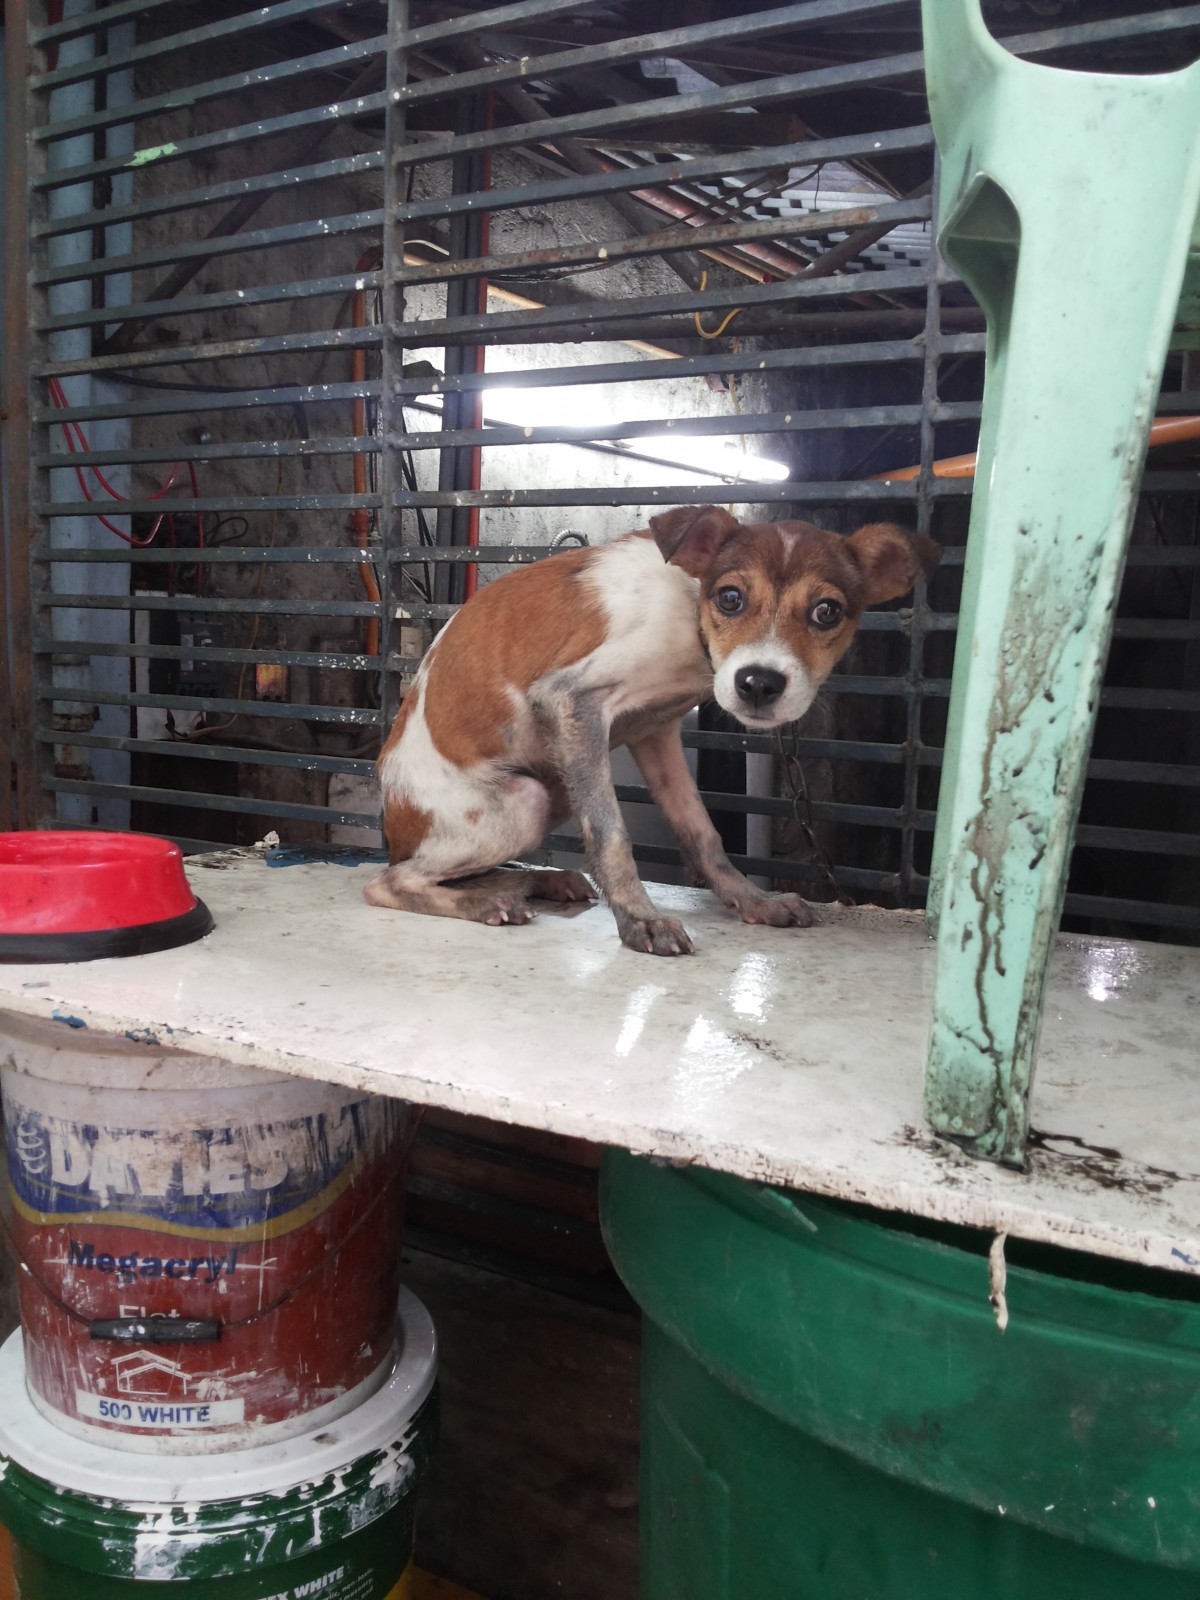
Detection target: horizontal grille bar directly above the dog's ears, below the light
<box><xmin>392</xmin><ymin>480</ymin><xmax>917</xmax><ymax>507</ymax></box>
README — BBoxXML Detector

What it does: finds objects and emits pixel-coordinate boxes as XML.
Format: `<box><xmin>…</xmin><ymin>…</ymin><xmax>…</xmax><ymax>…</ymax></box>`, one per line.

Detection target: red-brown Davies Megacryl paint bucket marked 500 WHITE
<box><xmin>0</xmin><ymin>1013</ymin><xmax>411</xmax><ymax>1454</ymax></box>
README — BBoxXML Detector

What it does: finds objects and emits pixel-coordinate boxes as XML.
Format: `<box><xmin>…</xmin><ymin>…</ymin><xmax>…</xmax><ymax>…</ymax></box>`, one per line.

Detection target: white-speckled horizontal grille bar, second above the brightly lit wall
<box><xmin>392</xmin><ymin>198</ymin><xmax>931</xmax><ymax>291</ymax></box>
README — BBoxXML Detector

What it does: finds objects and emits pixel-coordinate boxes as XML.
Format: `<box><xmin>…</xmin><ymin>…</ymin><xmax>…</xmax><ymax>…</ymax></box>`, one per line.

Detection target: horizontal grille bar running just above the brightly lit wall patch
<box><xmin>389</xmin><ymin>267</ymin><xmax>925</xmax><ymax>346</ymax></box>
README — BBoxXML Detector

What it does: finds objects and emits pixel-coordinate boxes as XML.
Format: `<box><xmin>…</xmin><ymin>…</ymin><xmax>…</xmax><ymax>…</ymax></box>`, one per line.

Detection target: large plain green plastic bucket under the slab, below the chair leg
<box><xmin>602</xmin><ymin>1152</ymin><xmax>1200</xmax><ymax>1600</ymax></box>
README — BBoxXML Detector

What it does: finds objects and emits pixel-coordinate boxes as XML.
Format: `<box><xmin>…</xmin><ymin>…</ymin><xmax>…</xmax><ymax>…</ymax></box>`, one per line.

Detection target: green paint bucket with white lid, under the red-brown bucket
<box><xmin>0</xmin><ymin>1291</ymin><xmax>437</xmax><ymax>1600</ymax></box>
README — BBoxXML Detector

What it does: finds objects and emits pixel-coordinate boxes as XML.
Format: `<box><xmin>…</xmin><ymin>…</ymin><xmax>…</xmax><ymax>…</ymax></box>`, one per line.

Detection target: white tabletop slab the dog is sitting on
<box><xmin>0</xmin><ymin>853</ymin><xmax>1200</xmax><ymax>1274</ymax></box>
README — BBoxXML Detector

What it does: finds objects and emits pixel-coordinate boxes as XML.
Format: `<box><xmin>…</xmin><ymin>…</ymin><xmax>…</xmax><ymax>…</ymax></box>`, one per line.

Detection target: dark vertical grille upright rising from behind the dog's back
<box><xmin>379</xmin><ymin>0</ymin><xmax>408</xmax><ymax>738</ymax></box>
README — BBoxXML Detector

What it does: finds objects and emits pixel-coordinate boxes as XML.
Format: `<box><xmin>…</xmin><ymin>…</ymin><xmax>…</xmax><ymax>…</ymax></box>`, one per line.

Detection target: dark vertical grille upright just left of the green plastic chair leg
<box><xmin>899</xmin><ymin>150</ymin><xmax>942</xmax><ymax>906</ymax></box>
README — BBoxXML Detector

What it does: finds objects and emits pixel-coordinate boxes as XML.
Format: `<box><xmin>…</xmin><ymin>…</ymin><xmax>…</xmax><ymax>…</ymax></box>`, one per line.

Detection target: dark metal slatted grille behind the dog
<box><xmin>0</xmin><ymin>0</ymin><xmax>1200</xmax><ymax>938</ymax></box>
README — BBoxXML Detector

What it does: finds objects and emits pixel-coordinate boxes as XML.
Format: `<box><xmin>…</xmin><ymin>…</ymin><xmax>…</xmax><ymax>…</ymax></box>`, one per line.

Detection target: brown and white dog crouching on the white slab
<box><xmin>365</xmin><ymin>506</ymin><xmax>941</xmax><ymax>955</ymax></box>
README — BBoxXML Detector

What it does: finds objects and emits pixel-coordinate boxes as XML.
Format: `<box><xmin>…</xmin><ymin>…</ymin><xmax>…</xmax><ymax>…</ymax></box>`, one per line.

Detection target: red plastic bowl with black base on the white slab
<box><xmin>0</xmin><ymin>832</ymin><xmax>213</xmax><ymax>962</ymax></box>
